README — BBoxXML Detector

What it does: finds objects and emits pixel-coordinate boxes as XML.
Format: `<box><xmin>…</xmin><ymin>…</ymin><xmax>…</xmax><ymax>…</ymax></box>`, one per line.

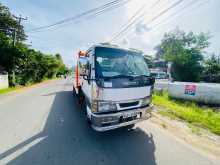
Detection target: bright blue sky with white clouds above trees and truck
<box><xmin>1</xmin><ymin>0</ymin><xmax>220</xmax><ymax>66</ymax></box>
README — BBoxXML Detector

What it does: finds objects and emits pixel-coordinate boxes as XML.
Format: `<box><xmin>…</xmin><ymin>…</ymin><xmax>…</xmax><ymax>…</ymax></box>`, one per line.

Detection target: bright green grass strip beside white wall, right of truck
<box><xmin>153</xmin><ymin>92</ymin><xmax>220</xmax><ymax>135</ymax></box>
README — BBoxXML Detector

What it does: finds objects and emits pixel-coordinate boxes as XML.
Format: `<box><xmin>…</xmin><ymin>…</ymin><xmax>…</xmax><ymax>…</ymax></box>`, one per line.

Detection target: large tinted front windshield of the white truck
<box><xmin>95</xmin><ymin>47</ymin><xmax>150</xmax><ymax>78</ymax></box>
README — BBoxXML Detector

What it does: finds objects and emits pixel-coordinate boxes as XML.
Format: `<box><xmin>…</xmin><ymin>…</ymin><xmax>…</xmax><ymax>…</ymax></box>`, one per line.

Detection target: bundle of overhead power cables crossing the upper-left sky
<box><xmin>27</xmin><ymin>0</ymin><xmax>131</xmax><ymax>32</ymax></box>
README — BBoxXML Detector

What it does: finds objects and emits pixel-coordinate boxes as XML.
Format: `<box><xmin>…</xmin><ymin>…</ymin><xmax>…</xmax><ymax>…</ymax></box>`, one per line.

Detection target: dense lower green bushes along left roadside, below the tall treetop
<box><xmin>0</xmin><ymin>33</ymin><xmax>68</xmax><ymax>85</ymax></box>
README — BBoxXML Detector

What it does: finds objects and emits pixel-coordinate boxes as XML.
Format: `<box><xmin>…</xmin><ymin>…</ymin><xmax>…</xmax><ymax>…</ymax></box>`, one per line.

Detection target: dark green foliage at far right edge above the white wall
<box><xmin>203</xmin><ymin>54</ymin><xmax>220</xmax><ymax>83</ymax></box>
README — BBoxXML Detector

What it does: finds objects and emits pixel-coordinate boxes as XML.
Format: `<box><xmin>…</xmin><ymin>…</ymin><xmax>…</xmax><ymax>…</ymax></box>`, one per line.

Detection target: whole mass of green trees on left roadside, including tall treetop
<box><xmin>0</xmin><ymin>3</ymin><xmax>69</xmax><ymax>86</ymax></box>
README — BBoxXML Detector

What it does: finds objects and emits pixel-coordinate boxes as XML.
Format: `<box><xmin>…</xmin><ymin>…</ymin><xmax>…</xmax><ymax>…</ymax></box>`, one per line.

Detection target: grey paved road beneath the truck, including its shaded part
<box><xmin>0</xmin><ymin>80</ymin><xmax>220</xmax><ymax>165</ymax></box>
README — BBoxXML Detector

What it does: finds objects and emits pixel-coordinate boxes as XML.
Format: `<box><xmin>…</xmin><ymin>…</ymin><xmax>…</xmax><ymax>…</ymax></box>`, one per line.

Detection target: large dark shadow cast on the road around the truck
<box><xmin>0</xmin><ymin>87</ymin><xmax>156</xmax><ymax>165</ymax></box>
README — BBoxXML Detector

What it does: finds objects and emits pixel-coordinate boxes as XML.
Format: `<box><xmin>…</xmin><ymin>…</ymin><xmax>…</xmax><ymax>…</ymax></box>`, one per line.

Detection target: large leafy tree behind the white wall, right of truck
<box><xmin>156</xmin><ymin>29</ymin><xmax>210</xmax><ymax>82</ymax></box>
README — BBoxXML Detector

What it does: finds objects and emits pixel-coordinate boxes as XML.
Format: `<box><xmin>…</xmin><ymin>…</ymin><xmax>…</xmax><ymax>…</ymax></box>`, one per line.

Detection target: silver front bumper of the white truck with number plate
<box><xmin>91</xmin><ymin>105</ymin><xmax>153</xmax><ymax>132</ymax></box>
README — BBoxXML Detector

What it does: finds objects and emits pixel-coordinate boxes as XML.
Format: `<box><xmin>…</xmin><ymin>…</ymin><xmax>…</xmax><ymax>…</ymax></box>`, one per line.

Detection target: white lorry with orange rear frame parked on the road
<box><xmin>73</xmin><ymin>44</ymin><xmax>155</xmax><ymax>132</ymax></box>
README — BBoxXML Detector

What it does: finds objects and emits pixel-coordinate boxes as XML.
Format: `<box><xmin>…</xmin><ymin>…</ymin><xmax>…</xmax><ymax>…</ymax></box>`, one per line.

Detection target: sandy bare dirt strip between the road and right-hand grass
<box><xmin>150</xmin><ymin>111</ymin><xmax>220</xmax><ymax>160</ymax></box>
